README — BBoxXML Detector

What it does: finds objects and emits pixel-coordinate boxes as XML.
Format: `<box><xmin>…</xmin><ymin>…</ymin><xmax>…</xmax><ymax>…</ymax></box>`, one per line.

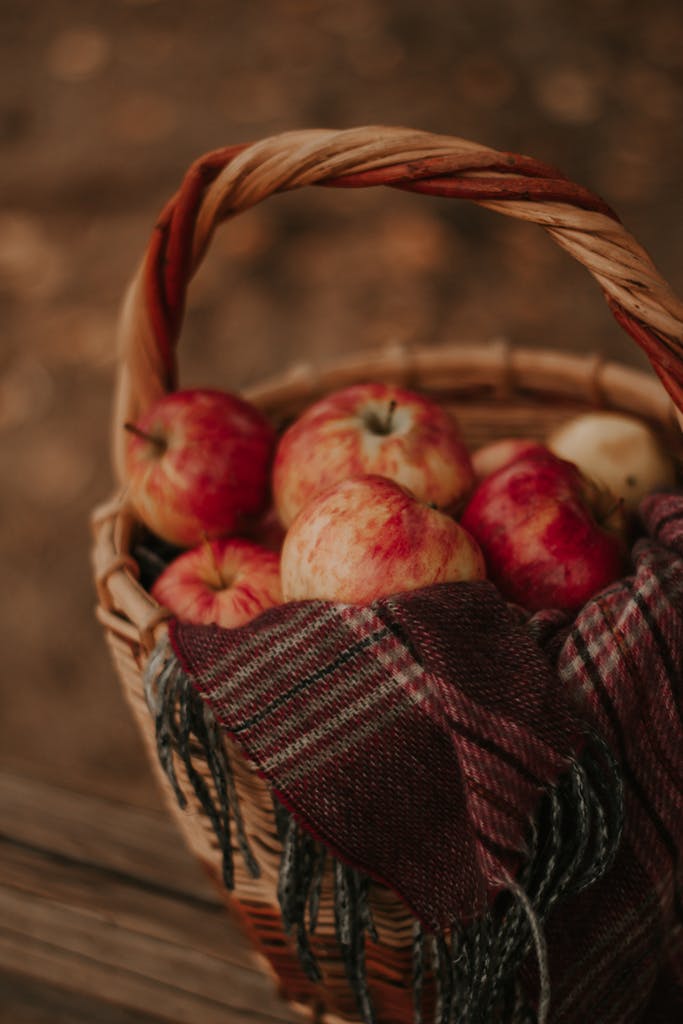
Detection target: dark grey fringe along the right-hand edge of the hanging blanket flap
<box><xmin>405</xmin><ymin>736</ymin><xmax>624</xmax><ymax>1024</ymax></box>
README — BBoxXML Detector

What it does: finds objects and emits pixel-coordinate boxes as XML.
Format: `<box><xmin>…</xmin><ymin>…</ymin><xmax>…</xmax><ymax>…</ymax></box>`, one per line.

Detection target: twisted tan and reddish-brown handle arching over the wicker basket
<box><xmin>114</xmin><ymin>126</ymin><xmax>683</xmax><ymax>478</ymax></box>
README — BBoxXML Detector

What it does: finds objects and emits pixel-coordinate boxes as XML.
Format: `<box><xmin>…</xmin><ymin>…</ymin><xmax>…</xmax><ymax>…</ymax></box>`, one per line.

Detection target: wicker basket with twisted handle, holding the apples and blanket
<box><xmin>92</xmin><ymin>127</ymin><xmax>683</xmax><ymax>1024</ymax></box>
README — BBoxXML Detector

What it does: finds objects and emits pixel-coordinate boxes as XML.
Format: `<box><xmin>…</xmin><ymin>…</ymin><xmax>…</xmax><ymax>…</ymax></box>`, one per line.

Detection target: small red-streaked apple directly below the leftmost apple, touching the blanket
<box><xmin>152</xmin><ymin>537</ymin><xmax>283</xmax><ymax>629</ymax></box>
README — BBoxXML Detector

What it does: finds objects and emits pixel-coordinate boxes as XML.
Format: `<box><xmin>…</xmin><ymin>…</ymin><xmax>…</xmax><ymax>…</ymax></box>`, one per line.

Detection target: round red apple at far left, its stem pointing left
<box><xmin>126</xmin><ymin>388</ymin><xmax>275</xmax><ymax>548</ymax></box>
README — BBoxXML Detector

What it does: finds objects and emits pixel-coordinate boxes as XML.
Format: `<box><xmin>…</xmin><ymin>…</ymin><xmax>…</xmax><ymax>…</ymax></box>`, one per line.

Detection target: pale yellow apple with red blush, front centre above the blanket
<box><xmin>282</xmin><ymin>474</ymin><xmax>484</xmax><ymax>604</ymax></box>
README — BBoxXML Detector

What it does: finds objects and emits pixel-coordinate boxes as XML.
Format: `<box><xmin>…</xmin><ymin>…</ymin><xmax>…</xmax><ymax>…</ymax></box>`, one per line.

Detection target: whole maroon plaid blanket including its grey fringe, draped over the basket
<box><xmin>147</xmin><ymin>495</ymin><xmax>683</xmax><ymax>1024</ymax></box>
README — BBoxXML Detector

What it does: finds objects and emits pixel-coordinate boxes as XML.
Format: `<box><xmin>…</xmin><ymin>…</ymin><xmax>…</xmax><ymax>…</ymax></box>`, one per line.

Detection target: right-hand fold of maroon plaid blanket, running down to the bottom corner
<box><xmin>532</xmin><ymin>496</ymin><xmax>683</xmax><ymax>1024</ymax></box>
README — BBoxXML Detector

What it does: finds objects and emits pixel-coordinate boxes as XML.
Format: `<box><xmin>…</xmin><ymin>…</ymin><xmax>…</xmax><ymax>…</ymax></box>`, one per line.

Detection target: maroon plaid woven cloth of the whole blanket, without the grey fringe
<box><xmin>166</xmin><ymin>496</ymin><xmax>683</xmax><ymax>1024</ymax></box>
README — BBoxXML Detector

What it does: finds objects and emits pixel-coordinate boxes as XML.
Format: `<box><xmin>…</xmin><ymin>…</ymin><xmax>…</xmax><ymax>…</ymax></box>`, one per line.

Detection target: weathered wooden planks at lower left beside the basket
<box><xmin>0</xmin><ymin>772</ymin><xmax>300</xmax><ymax>1024</ymax></box>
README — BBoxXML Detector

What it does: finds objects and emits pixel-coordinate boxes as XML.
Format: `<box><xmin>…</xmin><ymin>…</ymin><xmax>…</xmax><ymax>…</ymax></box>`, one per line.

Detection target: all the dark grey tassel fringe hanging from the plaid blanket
<box><xmin>144</xmin><ymin>642</ymin><xmax>624</xmax><ymax>1024</ymax></box>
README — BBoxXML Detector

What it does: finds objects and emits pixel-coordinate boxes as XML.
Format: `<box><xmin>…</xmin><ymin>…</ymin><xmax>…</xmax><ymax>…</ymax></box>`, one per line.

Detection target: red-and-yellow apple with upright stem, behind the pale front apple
<box><xmin>272</xmin><ymin>384</ymin><xmax>474</xmax><ymax>527</ymax></box>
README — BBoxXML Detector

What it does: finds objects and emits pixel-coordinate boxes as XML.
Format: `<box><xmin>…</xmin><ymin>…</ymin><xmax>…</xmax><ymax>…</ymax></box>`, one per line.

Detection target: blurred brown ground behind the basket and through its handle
<box><xmin>0</xmin><ymin>0</ymin><xmax>683</xmax><ymax>950</ymax></box>
